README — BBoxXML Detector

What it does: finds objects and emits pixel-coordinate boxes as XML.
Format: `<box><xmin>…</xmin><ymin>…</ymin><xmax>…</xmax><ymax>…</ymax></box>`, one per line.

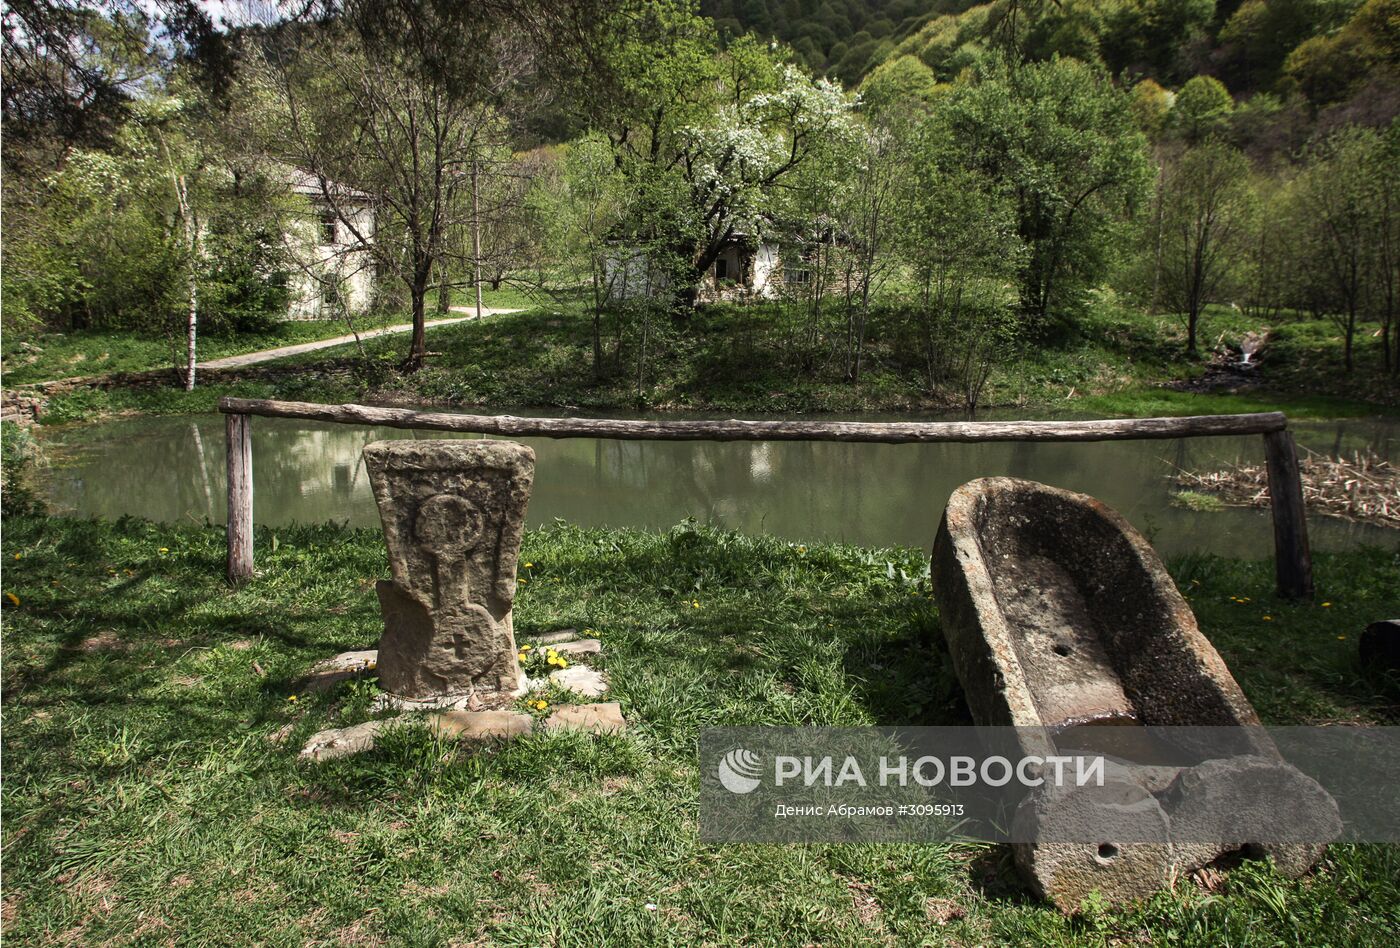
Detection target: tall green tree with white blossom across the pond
<box><xmin>590</xmin><ymin>0</ymin><xmax>850</xmax><ymax>301</ymax></box>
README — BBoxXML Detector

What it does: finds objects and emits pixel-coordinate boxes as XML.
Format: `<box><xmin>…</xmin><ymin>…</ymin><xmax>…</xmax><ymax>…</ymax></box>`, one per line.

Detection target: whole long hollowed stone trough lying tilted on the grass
<box><xmin>932</xmin><ymin>478</ymin><xmax>1340</xmax><ymax>912</ymax></box>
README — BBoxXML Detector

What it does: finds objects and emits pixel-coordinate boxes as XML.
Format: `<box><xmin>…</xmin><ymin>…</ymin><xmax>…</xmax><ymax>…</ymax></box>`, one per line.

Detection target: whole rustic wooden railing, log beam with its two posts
<box><xmin>218</xmin><ymin>398</ymin><xmax>1313</xmax><ymax>598</ymax></box>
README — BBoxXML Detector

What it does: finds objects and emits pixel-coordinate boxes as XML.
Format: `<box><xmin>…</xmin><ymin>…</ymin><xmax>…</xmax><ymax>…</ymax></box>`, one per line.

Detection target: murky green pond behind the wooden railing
<box><xmin>39</xmin><ymin>414</ymin><xmax>1400</xmax><ymax>557</ymax></box>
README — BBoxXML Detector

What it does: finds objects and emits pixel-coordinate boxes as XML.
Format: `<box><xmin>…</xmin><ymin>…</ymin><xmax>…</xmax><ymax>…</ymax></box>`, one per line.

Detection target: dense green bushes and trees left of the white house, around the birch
<box><xmin>4</xmin><ymin>89</ymin><xmax>298</xmax><ymax>344</ymax></box>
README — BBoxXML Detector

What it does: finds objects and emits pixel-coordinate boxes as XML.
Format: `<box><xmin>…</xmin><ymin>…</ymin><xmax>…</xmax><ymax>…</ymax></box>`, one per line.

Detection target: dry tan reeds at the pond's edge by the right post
<box><xmin>1176</xmin><ymin>448</ymin><xmax>1400</xmax><ymax>529</ymax></box>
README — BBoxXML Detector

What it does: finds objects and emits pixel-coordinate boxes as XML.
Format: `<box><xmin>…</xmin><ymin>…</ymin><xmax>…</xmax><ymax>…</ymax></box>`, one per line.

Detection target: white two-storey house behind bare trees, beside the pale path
<box><xmin>286</xmin><ymin>169</ymin><xmax>375</xmax><ymax>319</ymax></box>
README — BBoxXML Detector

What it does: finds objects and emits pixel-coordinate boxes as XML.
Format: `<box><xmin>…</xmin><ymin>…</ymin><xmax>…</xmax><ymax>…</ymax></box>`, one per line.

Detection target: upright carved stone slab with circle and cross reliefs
<box><xmin>364</xmin><ymin>441</ymin><xmax>535</xmax><ymax>699</ymax></box>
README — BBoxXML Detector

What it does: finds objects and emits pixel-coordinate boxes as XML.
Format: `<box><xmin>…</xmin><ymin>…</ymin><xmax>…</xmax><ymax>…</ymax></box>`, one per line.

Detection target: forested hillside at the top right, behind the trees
<box><xmin>700</xmin><ymin>0</ymin><xmax>1400</xmax><ymax>141</ymax></box>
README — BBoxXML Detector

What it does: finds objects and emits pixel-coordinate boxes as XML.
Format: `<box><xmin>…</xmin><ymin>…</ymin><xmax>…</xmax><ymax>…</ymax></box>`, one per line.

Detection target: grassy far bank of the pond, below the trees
<box><xmin>27</xmin><ymin>294</ymin><xmax>1400</xmax><ymax>421</ymax></box>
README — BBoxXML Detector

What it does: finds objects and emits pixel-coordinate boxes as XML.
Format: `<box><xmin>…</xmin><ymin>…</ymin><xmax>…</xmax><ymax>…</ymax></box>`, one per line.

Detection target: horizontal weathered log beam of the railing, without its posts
<box><xmin>218</xmin><ymin>398</ymin><xmax>1288</xmax><ymax>444</ymax></box>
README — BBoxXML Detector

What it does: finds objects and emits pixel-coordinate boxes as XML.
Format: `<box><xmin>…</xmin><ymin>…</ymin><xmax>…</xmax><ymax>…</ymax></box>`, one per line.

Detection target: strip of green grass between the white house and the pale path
<box><xmin>3</xmin><ymin>312</ymin><xmax>405</xmax><ymax>385</ymax></box>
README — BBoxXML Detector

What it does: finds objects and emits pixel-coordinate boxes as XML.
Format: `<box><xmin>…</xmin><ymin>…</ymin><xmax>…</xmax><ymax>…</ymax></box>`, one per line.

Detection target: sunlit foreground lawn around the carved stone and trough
<box><xmin>3</xmin><ymin>517</ymin><xmax>1400</xmax><ymax>945</ymax></box>
